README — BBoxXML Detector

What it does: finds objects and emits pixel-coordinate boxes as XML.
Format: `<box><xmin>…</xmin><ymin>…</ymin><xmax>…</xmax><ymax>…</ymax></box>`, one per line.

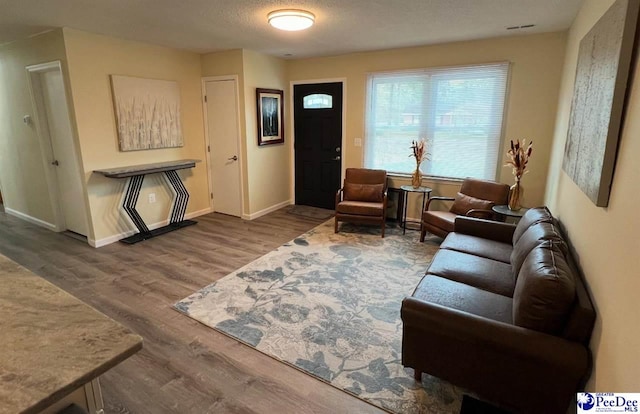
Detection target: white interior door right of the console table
<box><xmin>205</xmin><ymin>79</ymin><xmax>242</xmax><ymax>217</ymax></box>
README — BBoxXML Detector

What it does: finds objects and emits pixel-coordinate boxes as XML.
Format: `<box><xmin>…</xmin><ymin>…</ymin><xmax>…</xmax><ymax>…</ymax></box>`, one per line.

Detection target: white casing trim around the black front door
<box><xmin>289</xmin><ymin>78</ymin><xmax>347</xmax><ymax>204</ymax></box>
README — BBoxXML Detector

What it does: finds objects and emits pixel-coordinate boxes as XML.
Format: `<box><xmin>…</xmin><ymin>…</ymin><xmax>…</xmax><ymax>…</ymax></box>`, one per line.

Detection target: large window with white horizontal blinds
<box><xmin>365</xmin><ymin>63</ymin><xmax>509</xmax><ymax>179</ymax></box>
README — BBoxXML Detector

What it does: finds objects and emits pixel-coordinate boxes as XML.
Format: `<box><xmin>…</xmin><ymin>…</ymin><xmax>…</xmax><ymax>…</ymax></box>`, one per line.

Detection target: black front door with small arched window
<box><xmin>293</xmin><ymin>82</ymin><xmax>342</xmax><ymax>210</ymax></box>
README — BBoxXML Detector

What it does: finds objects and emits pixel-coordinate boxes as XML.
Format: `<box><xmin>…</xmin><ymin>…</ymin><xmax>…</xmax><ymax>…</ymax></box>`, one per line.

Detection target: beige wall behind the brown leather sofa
<box><xmin>546</xmin><ymin>0</ymin><xmax>640</xmax><ymax>392</ymax></box>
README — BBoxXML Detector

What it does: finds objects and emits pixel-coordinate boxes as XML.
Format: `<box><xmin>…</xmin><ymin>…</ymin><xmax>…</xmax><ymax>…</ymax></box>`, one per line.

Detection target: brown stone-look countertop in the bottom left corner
<box><xmin>0</xmin><ymin>255</ymin><xmax>142</xmax><ymax>414</ymax></box>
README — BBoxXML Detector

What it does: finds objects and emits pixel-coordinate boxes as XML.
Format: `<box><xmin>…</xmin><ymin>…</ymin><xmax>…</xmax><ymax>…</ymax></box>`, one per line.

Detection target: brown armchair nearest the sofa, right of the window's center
<box><xmin>420</xmin><ymin>178</ymin><xmax>509</xmax><ymax>241</ymax></box>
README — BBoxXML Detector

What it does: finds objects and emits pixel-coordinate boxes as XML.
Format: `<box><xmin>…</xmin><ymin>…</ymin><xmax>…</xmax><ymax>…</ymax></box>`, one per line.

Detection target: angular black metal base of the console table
<box><xmin>120</xmin><ymin>170</ymin><xmax>197</xmax><ymax>244</ymax></box>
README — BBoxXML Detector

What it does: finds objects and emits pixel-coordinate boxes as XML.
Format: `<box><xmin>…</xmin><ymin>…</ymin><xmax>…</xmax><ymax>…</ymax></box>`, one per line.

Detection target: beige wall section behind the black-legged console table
<box><xmin>63</xmin><ymin>28</ymin><xmax>209</xmax><ymax>243</ymax></box>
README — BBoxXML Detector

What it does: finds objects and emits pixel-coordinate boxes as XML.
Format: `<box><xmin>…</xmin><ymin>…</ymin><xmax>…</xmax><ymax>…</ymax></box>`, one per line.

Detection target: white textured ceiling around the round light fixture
<box><xmin>0</xmin><ymin>0</ymin><xmax>583</xmax><ymax>58</ymax></box>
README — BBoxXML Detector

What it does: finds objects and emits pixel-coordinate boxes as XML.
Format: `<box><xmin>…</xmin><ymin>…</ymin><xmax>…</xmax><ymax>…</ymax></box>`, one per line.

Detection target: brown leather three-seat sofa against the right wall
<box><xmin>401</xmin><ymin>207</ymin><xmax>595</xmax><ymax>413</ymax></box>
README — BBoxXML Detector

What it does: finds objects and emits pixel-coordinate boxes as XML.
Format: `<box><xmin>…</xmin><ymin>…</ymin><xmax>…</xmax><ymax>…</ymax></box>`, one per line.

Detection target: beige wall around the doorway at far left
<box><xmin>0</xmin><ymin>30</ymin><xmax>72</xmax><ymax>226</ymax></box>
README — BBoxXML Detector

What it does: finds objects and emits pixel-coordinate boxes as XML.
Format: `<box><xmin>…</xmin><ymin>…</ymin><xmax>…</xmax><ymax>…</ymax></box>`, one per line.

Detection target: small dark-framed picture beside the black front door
<box><xmin>256</xmin><ymin>88</ymin><xmax>284</xmax><ymax>145</ymax></box>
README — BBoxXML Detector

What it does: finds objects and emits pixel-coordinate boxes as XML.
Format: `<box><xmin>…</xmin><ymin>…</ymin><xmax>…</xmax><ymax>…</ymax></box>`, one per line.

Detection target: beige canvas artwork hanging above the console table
<box><xmin>111</xmin><ymin>75</ymin><xmax>184</xmax><ymax>151</ymax></box>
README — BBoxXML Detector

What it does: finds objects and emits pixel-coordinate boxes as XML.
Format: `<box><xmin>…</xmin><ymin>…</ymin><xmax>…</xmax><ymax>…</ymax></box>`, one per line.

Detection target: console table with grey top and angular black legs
<box><xmin>94</xmin><ymin>160</ymin><xmax>200</xmax><ymax>244</ymax></box>
